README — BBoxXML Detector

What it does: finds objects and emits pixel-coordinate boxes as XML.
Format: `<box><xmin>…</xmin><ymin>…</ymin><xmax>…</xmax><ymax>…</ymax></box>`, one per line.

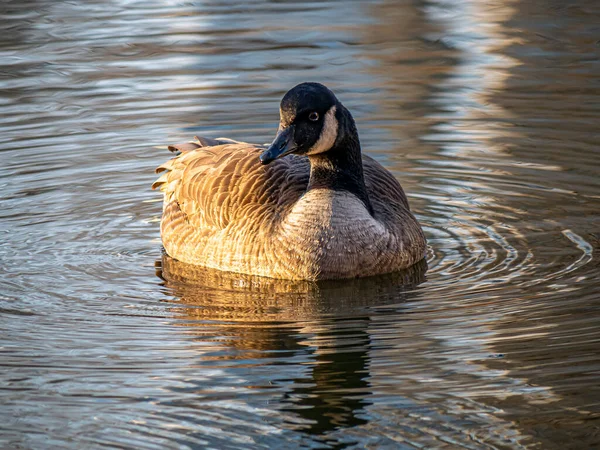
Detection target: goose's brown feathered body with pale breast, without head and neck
<box><xmin>153</xmin><ymin>140</ymin><xmax>425</xmax><ymax>280</ymax></box>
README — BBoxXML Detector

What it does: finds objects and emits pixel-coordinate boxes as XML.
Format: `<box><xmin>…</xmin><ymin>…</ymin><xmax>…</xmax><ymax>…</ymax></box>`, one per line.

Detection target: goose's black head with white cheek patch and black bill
<box><xmin>260</xmin><ymin>83</ymin><xmax>343</xmax><ymax>164</ymax></box>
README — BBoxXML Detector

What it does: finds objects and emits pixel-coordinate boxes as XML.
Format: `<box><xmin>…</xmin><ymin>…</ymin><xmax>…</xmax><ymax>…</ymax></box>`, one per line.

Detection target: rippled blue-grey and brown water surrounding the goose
<box><xmin>0</xmin><ymin>0</ymin><xmax>600</xmax><ymax>449</ymax></box>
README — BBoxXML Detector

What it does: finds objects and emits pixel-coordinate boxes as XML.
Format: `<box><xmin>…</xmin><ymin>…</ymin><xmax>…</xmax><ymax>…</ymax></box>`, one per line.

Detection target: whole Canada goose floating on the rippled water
<box><xmin>152</xmin><ymin>83</ymin><xmax>426</xmax><ymax>280</ymax></box>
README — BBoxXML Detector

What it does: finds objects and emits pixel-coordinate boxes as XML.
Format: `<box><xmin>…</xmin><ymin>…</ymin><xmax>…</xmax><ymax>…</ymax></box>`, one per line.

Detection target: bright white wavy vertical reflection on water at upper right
<box><xmin>425</xmin><ymin>0</ymin><xmax>520</xmax><ymax>159</ymax></box>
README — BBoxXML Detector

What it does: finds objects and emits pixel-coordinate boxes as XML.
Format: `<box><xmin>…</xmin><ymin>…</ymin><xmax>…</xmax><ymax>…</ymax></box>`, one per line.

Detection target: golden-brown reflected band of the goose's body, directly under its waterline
<box><xmin>157</xmin><ymin>255</ymin><xmax>427</xmax><ymax>323</ymax></box>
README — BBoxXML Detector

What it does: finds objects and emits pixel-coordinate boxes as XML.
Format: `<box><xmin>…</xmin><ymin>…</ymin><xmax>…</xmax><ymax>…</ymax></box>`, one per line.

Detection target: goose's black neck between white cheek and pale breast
<box><xmin>308</xmin><ymin>105</ymin><xmax>373</xmax><ymax>215</ymax></box>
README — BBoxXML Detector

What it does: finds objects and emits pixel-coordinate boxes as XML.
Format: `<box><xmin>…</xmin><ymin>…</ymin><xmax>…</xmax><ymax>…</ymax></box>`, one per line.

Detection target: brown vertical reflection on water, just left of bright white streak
<box><xmin>361</xmin><ymin>0</ymin><xmax>456</xmax><ymax>156</ymax></box>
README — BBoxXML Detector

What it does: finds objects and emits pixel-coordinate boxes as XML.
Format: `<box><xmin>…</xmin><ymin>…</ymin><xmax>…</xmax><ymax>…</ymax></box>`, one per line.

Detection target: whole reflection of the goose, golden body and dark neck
<box><xmin>157</xmin><ymin>255</ymin><xmax>427</xmax><ymax>436</ymax></box>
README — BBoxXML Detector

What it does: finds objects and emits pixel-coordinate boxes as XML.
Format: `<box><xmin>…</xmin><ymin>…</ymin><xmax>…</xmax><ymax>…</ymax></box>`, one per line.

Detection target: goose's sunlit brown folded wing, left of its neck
<box><xmin>152</xmin><ymin>140</ymin><xmax>309</xmax><ymax>260</ymax></box>
